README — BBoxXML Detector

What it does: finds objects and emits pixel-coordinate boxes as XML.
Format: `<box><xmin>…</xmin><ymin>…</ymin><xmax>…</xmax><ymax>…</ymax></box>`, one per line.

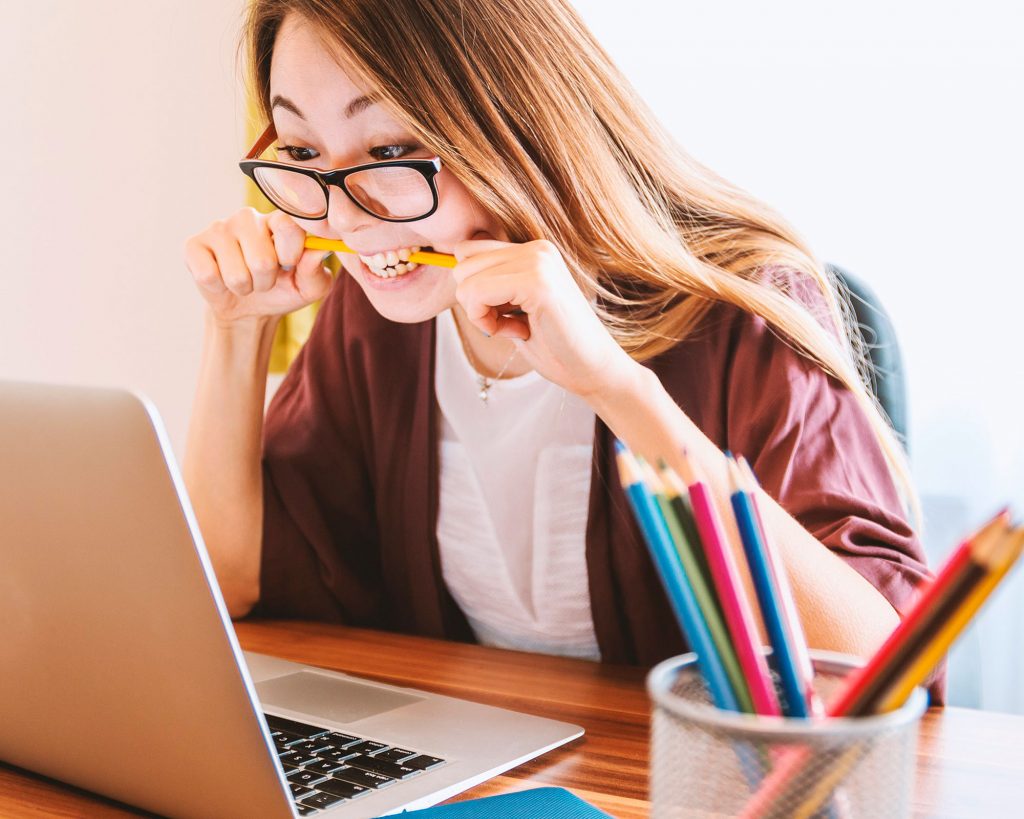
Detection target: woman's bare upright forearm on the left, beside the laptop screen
<box><xmin>183</xmin><ymin>315</ymin><xmax>276</xmax><ymax>616</ymax></box>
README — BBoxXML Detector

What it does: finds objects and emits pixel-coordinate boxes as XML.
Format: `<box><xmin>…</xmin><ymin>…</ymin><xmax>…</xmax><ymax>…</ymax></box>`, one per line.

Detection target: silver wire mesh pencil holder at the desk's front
<box><xmin>647</xmin><ymin>651</ymin><xmax>928</xmax><ymax>819</ymax></box>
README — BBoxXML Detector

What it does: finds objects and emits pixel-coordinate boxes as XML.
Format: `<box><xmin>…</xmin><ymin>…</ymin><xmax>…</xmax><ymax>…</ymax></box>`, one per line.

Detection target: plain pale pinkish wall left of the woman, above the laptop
<box><xmin>0</xmin><ymin>0</ymin><xmax>244</xmax><ymax>454</ymax></box>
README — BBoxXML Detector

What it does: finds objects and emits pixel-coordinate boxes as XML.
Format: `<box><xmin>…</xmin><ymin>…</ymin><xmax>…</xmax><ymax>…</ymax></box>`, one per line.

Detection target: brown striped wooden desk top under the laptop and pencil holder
<box><xmin>0</xmin><ymin>622</ymin><xmax>1024</xmax><ymax>819</ymax></box>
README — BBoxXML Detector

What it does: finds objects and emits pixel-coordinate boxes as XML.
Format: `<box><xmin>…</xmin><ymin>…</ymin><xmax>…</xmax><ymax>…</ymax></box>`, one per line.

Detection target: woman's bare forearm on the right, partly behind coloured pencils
<box><xmin>588</xmin><ymin>364</ymin><xmax>898</xmax><ymax>656</ymax></box>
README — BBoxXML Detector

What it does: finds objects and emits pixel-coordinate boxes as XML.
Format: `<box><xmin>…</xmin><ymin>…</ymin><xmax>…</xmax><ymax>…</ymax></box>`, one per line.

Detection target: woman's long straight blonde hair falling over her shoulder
<box><xmin>244</xmin><ymin>0</ymin><xmax>920</xmax><ymax>519</ymax></box>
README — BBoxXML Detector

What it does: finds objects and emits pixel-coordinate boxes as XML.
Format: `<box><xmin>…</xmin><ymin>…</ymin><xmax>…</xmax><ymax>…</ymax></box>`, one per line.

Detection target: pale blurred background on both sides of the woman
<box><xmin>0</xmin><ymin>0</ymin><xmax>1024</xmax><ymax>713</ymax></box>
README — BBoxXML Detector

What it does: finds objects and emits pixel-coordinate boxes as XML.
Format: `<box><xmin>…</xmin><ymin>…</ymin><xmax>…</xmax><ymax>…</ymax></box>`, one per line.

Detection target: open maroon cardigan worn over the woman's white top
<box><xmin>256</xmin><ymin>274</ymin><xmax>929</xmax><ymax>683</ymax></box>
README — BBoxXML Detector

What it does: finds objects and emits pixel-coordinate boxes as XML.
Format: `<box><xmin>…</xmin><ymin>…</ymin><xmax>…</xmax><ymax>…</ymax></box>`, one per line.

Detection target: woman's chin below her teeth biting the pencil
<box><xmin>342</xmin><ymin>256</ymin><xmax>455</xmax><ymax>325</ymax></box>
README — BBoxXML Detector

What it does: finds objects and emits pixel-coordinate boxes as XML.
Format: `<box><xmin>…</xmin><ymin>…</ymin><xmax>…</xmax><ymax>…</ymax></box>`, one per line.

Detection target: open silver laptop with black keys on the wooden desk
<box><xmin>0</xmin><ymin>382</ymin><xmax>583</xmax><ymax>819</ymax></box>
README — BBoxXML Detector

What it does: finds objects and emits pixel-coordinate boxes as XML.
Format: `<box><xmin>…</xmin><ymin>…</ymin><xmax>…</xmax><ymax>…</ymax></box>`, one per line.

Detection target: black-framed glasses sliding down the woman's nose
<box><xmin>239</xmin><ymin>123</ymin><xmax>441</xmax><ymax>222</ymax></box>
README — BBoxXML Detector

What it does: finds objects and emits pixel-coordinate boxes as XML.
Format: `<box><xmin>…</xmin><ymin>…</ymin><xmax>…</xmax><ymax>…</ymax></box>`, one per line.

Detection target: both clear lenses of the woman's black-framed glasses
<box><xmin>255</xmin><ymin>166</ymin><xmax>434</xmax><ymax>219</ymax></box>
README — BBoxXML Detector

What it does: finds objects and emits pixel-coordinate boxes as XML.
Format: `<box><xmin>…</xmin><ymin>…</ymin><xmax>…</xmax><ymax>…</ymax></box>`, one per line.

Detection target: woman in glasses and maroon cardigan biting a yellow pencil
<box><xmin>185</xmin><ymin>0</ymin><xmax>927</xmax><ymax>663</ymax></box>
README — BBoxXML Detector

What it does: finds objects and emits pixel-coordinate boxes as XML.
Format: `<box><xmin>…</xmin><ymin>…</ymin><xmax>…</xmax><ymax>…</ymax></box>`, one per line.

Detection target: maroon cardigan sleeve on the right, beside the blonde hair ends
<box><xmin>725</xmin><ymin>294</ymin><xmax>931</xmax><ymax>613</ymax></box>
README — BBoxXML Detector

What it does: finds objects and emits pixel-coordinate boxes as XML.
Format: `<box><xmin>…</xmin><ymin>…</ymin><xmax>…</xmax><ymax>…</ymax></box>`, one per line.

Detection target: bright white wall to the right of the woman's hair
<box><xmin>577</xmin><ymin>0</ymin><xmax>1024</xmax><ymax>712</ymax></box>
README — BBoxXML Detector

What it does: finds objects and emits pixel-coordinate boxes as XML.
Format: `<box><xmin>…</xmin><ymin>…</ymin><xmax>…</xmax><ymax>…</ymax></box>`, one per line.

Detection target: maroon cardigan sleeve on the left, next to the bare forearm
<box><xmin>254</xmin><ymin>285</ymin><xmax>384</xmax><ymax>626</ymax></box>
